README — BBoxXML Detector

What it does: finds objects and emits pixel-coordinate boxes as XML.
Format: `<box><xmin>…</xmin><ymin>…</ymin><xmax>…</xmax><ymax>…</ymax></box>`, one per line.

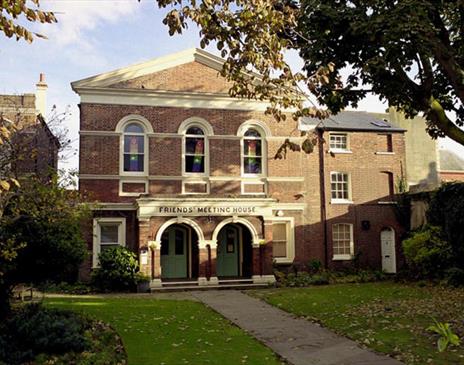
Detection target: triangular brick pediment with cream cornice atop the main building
<box><xmin>71</xmin><ymin>48</ymin><xmax>239</xmax><ymax>93</ymax></box>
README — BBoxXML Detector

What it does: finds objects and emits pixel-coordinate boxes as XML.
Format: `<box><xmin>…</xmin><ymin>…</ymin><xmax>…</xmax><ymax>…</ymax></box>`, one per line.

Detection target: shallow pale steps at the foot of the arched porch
<box><xmin>150</xmin><ymin>278</ymin><xmax>269</xmax><ymax>293</ymax></box>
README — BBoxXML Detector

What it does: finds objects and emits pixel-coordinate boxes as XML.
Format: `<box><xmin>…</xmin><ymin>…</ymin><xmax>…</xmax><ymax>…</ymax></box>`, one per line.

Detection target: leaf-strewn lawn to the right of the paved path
<box><xmin>252</xmin><ymin>282</ymin><xmax>464</xmax><ymax>365</ymax></box>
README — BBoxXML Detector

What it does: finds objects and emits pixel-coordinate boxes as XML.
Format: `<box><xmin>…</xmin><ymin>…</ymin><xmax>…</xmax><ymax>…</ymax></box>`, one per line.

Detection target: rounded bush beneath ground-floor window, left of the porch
<box><xmin>92</xmin><ymin>246</ymin><xmax>141</xmax><ymax>291</ymax></box>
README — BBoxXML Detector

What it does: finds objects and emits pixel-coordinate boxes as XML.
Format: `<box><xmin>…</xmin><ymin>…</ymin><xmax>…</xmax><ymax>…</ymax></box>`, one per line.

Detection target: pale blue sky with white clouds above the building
<box><xmin>0</xmin><ymin>0</ymin><xmax>464</xmax><ymax>169</ymax></box>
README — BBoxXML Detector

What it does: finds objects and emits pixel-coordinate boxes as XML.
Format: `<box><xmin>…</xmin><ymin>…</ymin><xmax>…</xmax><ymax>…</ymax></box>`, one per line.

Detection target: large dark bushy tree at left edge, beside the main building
<box><xmin>0</xmin><ymin>172</ymin><xmax>88</xmax><ymax>311</ymax></box>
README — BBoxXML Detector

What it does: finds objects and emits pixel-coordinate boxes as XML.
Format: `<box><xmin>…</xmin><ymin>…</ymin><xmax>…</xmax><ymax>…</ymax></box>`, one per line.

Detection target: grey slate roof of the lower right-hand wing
<box><xmin>299</xmin><ymin>111</ymin><xmax>406</xmax><ymax>132</ymax></box>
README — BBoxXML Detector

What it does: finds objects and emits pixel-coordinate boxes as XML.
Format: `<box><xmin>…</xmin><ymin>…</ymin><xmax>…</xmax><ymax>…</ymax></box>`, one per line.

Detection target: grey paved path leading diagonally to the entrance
<box><xmin>192</xmin><ymin>290</ymin><xmax>402</xmax><ymax>365</ymax></box>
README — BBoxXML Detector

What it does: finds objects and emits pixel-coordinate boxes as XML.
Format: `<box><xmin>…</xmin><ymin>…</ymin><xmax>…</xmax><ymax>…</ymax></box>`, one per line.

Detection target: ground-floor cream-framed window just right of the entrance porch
<box><xmin>272</xmin><ymin>218</ymin><xmax>295</xmax><ymax>263</ymax></box>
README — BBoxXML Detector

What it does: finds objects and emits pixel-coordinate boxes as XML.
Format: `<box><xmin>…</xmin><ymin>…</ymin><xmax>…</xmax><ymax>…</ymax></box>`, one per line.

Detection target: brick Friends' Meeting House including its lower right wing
<box><xmin>72</xmin><ymin>49</ymin><xmax>404</xmax><ymax>287</ymax></box>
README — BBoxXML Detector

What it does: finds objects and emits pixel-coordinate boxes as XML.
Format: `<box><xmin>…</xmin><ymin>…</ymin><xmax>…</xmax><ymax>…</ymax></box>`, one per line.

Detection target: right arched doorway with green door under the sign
<box><xmin>216</xmin><ymin>223</ymin><xmax>252</xmax><ymax>278</ymax></box>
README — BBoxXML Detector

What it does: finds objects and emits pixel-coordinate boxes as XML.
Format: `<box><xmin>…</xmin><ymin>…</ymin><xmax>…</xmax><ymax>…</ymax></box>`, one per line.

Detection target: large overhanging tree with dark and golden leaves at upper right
<box><xmin>158</xmin><ymin>0</ymin><xmax>464</xmax><ymax>146</ymax></box>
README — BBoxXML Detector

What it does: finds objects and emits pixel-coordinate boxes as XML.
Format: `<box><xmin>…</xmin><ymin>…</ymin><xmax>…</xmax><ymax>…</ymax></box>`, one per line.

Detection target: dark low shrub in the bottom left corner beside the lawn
<box><xmin>0</xmin><ymin>304</ymin><xmax>89</xmax><ymax>364</ymax></box>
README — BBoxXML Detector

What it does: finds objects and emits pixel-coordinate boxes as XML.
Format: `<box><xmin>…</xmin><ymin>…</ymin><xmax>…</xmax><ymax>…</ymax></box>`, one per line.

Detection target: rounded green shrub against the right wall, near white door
<box><xmin>403</xmin><ymin>226</ymin><xmax>453</xmax><ymax>278</ymax></box>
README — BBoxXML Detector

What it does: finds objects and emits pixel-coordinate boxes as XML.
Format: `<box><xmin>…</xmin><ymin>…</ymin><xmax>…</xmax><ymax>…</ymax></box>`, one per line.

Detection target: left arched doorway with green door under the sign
<box><xmin>160</xmin><ymin>224</ymin><xmax>199</xmax><ymax>280</ymax></box>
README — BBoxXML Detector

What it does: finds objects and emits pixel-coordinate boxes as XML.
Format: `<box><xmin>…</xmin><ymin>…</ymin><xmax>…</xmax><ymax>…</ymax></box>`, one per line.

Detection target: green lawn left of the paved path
<box><xmin>46</xmin><ymin>297</ymin><xmax>281</xmax><ymax>365</ymax></box>
